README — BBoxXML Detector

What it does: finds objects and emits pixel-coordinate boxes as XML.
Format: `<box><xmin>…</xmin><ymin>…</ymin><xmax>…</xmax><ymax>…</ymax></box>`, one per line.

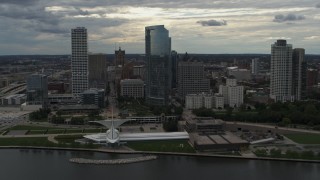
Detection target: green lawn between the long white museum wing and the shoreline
<box><xmin>127</xmin><ymin>140</ymin><xmax>195</xmax><ymax>153</ymax></box>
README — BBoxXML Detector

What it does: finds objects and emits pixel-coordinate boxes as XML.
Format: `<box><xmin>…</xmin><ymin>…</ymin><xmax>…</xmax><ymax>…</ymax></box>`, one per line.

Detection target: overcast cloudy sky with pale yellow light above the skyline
<box><xmin>0</xmin><ymin>0</ymin><xmax>320</xmax><ymax>55</ymax></box>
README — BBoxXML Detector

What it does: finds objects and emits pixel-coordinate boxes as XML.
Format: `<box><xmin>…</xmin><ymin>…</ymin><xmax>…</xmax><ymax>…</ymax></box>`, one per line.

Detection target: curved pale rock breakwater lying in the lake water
<box><xmin>69</xmin><ymin>155</ymin><xmax>157</xmax><ymax>165</ymax></box>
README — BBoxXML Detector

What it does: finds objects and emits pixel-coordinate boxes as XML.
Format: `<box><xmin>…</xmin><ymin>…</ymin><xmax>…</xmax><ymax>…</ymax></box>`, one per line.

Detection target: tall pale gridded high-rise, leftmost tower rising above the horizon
<box><xmin>71</xmin><ymin>27</ymin><xmax>89</xmax><ymax>98</ymax></box>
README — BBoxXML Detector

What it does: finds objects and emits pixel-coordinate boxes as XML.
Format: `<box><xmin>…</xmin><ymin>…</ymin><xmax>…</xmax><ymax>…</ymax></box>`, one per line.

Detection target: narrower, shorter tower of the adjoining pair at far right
<box><xmin>292</xmin><ymin>48</ymin><xmax>307</xmax><ymax>101</ymax></box>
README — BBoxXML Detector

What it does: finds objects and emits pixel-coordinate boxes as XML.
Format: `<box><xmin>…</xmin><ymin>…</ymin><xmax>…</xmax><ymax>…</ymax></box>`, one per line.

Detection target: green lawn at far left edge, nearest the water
<box><xmin>0</xmin><ymin>137</ymin><xmax>54</xmax><ymax>146</ymax></box>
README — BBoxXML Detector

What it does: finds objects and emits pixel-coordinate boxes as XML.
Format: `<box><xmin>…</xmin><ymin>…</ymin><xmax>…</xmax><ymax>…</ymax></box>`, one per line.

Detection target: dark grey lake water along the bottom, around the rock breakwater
<box><xmin>0</xmin><ymin>149</ymin><xmax>320</xmax><ymax>180</ymax></box>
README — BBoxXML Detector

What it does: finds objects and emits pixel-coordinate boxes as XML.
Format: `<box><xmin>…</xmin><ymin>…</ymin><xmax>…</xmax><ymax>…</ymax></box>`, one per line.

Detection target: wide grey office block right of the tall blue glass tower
<box><xmin>178</xmin><ymin>61</ymin><xmax>210</xmax><ymax>100</ymax></box>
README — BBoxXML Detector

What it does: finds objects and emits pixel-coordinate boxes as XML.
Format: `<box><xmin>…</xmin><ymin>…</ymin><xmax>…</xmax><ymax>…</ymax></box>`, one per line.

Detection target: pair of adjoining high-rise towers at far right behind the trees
<box><xmin>270</xmin><ymin>40</ymin><xmax>307</xmax><ymax>102</ymax></box>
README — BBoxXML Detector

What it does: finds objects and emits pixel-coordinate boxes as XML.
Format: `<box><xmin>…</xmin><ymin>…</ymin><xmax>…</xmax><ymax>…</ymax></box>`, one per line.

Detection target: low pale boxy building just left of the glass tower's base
<box><xmin>120</xmin><ymin>79</ymin><xmax>144</xmax><ymax>98</ymax></box>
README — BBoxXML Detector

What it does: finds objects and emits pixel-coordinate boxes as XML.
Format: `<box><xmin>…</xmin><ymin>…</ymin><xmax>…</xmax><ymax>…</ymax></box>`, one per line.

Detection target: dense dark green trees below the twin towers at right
<box><xmin>215</xmin><ymin>102</ymin><xmax>320</xmax><ymax>129</ymax></box>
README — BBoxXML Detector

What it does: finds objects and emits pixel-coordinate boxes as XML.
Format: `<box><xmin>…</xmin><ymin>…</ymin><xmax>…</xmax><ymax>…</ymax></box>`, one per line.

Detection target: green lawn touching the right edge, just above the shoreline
<box><xmin>285</xmin><ymin>134</ymin><xmax>320</xmax><ymax>144</ymax></box>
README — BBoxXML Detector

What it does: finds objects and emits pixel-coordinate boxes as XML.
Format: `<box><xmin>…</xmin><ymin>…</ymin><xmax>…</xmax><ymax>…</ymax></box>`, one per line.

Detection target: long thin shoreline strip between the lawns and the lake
<box><xmin>0</xmin><ymin>146</ymin><xmax>320</xmax><ymax>163</ymax></box>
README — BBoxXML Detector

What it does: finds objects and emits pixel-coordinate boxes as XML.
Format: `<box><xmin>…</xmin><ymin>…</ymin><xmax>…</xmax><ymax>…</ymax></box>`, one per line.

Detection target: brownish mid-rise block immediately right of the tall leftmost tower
<box><xmin>89</xmin><ymin>54</ymin><xmax>107</xmax><ymax>89</ymax></box>
